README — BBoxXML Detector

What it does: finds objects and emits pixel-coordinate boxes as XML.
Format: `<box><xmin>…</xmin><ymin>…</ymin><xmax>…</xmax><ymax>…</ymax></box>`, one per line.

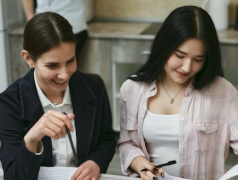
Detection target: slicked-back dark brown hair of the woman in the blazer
<box><xmin>23</xmin><ymin>12</ymin><xmax>75</xmax><ymax>61</ymax></box>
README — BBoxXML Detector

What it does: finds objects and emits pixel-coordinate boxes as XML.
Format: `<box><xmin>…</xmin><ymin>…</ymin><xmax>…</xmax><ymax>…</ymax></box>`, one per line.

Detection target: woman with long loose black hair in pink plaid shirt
<box><xmin>118</xmin><ymin>6</ymin><xmax>238</xmax><ymax>180</ymax></box>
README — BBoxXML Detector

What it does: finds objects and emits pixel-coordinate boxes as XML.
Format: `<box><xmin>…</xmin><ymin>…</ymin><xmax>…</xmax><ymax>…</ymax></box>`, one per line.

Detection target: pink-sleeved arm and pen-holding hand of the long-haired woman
<box><xmin>118</xmin><ymin>80</ymin><xmax>163</xmax><ymax>179</ymax></box>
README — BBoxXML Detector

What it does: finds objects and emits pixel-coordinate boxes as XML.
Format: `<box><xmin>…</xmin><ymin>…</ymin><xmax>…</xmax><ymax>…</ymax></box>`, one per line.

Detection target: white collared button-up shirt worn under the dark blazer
<box><xmin>34</xmin><ymin>72</ymin><xmax>77</xmax><ymax>166</ymax></box>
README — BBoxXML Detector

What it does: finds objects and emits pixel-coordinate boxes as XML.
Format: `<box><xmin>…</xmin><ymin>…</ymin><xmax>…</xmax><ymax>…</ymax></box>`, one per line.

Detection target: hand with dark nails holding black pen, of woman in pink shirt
<box><xmin>130</xmin><ymin>156</ymin><xmax>164</xmax><ymax>180</ymax></box>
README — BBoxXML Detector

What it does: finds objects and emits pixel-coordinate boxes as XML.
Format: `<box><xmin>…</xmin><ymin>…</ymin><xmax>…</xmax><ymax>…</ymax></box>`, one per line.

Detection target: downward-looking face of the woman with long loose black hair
<box><xmin>164</xmin><ymin>38</ymin><xmax>206</xmax><ymax>84</ymax></box>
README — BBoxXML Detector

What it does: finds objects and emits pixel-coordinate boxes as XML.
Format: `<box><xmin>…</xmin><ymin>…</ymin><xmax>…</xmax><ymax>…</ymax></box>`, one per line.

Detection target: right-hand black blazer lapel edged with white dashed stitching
<box><xmin>69</xmin><ymin>72</ymin><xmax>97</xmax><ymax>164</ymax></box>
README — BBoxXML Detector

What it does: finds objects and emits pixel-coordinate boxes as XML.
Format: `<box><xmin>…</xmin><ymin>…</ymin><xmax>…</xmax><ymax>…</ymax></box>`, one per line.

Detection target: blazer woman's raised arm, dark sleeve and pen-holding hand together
<box><xmin>0</xmin><ymin>85</ymin><xmax>74</xmax><ymax>180</ymax></box>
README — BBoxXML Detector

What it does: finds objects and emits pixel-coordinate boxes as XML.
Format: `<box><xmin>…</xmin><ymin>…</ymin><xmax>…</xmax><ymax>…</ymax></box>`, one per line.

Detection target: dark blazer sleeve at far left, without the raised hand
<box><xmin>0</xmin><ymin>86</ymin><xmax>44</xmax><ymax>180</ymax></box>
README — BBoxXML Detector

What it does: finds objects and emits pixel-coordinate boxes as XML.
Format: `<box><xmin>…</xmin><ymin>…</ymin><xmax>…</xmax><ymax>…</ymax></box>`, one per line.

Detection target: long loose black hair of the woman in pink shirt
<box><xmin>129</xmin><ymin>6</ymin><xmax>224</xmax><ymax>89</ymax></box>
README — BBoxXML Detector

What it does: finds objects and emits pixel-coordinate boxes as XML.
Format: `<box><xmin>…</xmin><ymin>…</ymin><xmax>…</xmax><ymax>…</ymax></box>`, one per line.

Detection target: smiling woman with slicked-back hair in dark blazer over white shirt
<box><xmin>0</xmin><ymin>12</ymin><xmax>116</xmax><ymax>180</ymax></box>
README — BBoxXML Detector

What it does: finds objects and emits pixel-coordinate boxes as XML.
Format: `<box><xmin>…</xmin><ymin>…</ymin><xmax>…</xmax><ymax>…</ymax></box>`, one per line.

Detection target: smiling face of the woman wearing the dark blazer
<box><xmin>24</xmin><ymin>43</ymin><xmax>77</xmax><ymax>98</ymax></box>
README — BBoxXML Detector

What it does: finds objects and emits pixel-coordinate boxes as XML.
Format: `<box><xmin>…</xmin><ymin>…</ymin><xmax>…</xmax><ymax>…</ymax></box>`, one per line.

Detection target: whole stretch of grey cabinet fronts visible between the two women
<box><xmin>78</xmin><ymin>38</ymin><xmax>152</xmax><ymax>131</ymax></box>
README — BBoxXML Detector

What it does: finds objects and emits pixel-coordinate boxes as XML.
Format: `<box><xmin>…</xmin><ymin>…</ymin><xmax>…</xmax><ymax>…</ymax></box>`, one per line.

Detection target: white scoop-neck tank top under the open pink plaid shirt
<box><xmin>143</xmin><ymin>110</ymin><xmax>180</xmax><ymax>176</ymax></box>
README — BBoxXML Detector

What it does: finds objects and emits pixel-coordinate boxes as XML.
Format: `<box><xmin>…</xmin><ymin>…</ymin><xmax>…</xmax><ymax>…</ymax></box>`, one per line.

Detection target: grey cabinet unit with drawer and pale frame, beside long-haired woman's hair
<box><xmin>111</xmin><ymin>39</ymin><xmax>151</xmax><ymax>131</ymax></box>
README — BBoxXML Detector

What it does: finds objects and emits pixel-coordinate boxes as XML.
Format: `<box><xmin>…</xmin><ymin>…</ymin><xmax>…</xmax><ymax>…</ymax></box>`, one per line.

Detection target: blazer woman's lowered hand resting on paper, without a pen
<box><xmin>70</xmin><ymin>160</ymin><xmax>100</xmax><ymax>180</ymax></box>
